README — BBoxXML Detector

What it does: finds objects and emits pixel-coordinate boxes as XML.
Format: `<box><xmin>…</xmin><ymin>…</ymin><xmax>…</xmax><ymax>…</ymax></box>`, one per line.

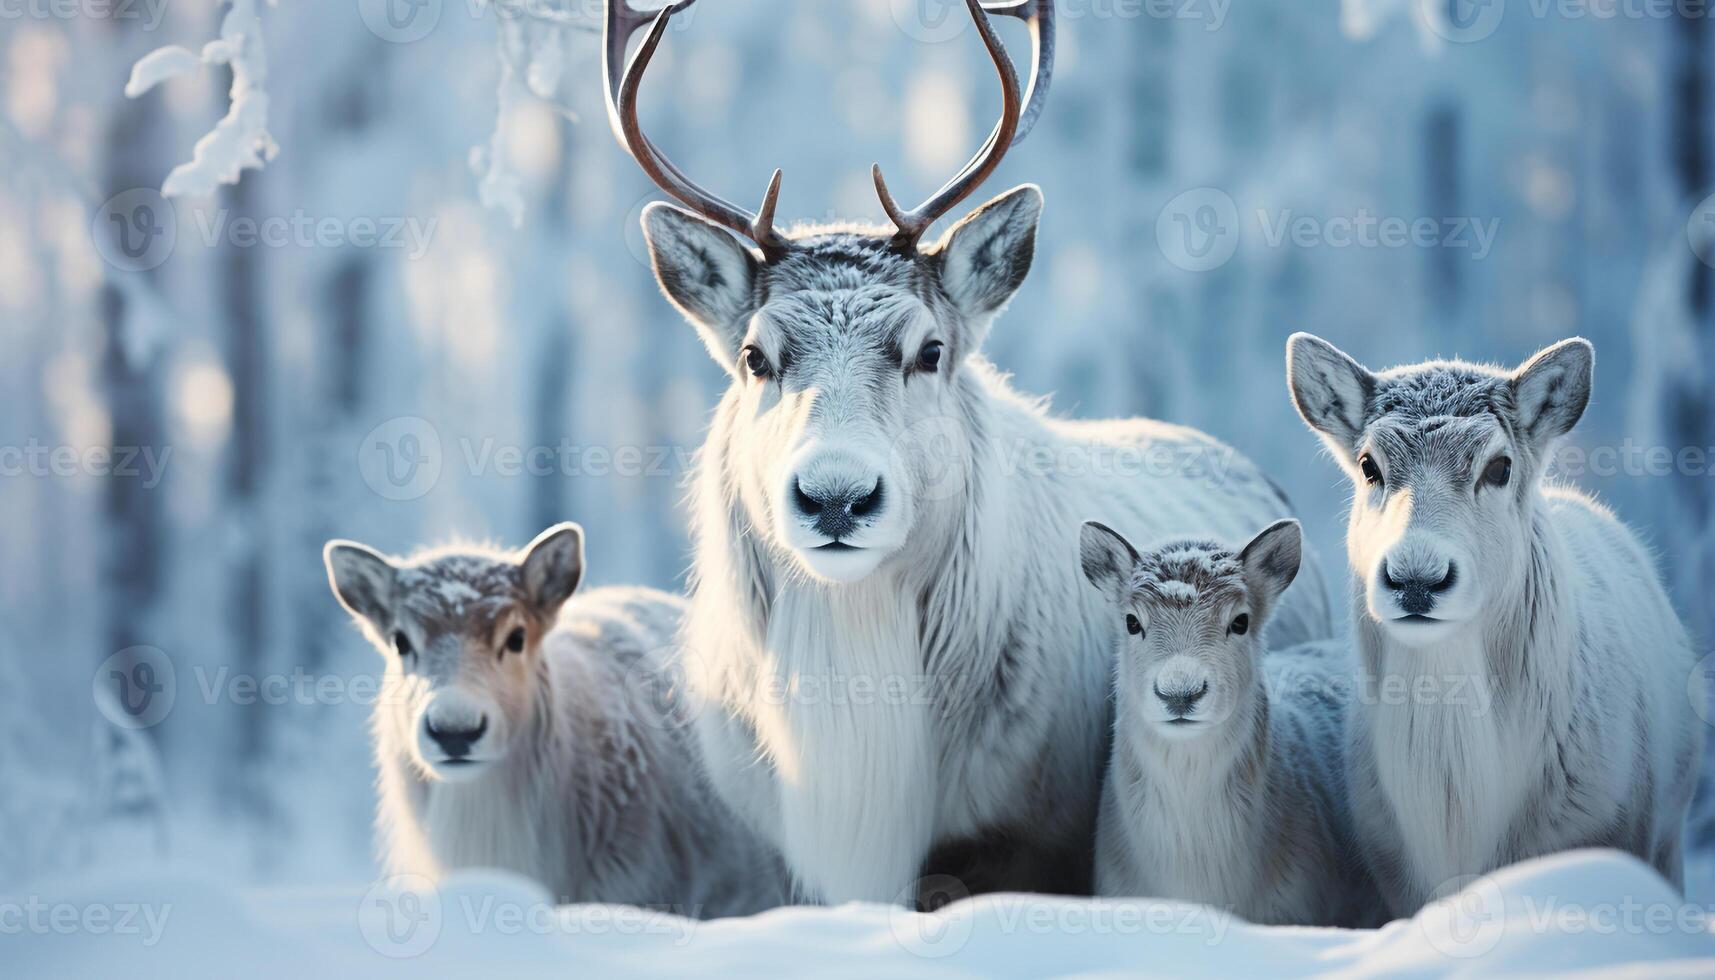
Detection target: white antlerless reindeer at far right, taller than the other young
<box><xmin>1286</xmin><ymin>333</ymin><xmax>1701</xmax><ymax>915</ymax></box>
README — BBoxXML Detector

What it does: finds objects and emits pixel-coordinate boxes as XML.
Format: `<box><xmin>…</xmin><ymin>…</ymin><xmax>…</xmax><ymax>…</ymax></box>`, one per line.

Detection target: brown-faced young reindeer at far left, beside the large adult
<box><xmin>326</xmin><ymin>523</ymin><xmax>787</xmax><ymax>916</ymax></box>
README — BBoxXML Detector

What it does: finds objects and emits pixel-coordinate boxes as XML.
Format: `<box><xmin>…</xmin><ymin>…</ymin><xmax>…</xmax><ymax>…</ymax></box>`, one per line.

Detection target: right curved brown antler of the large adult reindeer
<box><xmin>871</xmin><ymin>0</ymin><xmax>1055</xmax><ymax>251</ymax></box>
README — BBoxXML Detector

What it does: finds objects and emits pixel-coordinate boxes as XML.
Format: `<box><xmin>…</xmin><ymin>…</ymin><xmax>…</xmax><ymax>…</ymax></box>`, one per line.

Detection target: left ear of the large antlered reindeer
<box><xmin>643</xmin><ymin>201</ymin><xmax>761</xmax><ymax>378</ymax></box>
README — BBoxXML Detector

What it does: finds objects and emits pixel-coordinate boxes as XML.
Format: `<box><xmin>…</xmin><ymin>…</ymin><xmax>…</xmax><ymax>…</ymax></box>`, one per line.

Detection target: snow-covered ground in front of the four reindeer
<box><xmin>13</xmin><ymin>851</ymin><xmax>1715</xmax><ymax>980</ymax></box>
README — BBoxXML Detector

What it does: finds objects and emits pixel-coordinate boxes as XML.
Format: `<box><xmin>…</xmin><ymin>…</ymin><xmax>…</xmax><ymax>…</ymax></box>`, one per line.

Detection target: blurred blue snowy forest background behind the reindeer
<box><xmin>0</xmin><ymin>0</ymin><xmax>1715</xmax><ymax>896</ymax></box>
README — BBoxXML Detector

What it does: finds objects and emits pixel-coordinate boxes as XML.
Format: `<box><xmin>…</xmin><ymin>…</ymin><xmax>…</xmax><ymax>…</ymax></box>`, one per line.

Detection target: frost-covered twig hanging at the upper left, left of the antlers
<box><xmin>125</xmin><ymin>0</ymin><xmax>280</xmax><ymax>197</ymax></box>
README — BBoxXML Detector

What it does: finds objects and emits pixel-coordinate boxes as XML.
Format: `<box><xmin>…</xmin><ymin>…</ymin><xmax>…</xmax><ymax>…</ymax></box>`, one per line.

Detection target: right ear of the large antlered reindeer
<box><xmin>935</xmin><ymin>184</ymin><xmax>1043</xmax><ymax>329</ymax></box>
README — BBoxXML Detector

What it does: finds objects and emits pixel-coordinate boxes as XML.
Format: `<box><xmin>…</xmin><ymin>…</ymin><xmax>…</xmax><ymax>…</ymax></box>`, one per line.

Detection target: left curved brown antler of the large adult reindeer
<box><xmin>602</xmin><ymin>0</ymin><xmax>791</xmax><ymax>257</ymax></box>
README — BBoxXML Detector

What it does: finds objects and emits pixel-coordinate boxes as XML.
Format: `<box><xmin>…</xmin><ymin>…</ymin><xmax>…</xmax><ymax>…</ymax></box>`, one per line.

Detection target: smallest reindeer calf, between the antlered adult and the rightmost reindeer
<box><xmin>1080</xmin><ymin>520</ymin><xmax>1381</xmax><ymax>927</ymax></box>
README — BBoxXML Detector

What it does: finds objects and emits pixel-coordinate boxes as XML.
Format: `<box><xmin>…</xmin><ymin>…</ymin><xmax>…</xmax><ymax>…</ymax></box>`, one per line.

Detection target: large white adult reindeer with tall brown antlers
<box><xmin>607</xmin><ymin>0</ymin><xmax>1329</xmax><ymax>901</ymax></box>
